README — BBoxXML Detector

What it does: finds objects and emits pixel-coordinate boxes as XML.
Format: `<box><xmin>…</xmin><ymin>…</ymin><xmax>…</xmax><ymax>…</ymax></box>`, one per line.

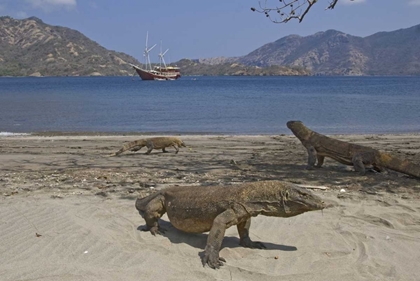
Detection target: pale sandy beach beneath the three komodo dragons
<box><xmin>0</xmin><ymin>134</ymin><xmax>420</xmax><ymax>281</ymax></box>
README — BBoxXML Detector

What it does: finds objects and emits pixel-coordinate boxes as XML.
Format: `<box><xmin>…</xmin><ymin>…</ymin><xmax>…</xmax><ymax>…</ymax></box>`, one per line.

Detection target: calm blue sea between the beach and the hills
<box><xmin>0</xmin><ymin>76</ymin><xmax>420</xmax><ymax>135</ymax></box>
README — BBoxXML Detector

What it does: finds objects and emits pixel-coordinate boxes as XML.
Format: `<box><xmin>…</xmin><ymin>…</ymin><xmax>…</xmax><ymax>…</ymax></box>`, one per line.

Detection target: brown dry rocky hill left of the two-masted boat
<box><xmin>0</xmin><ymin>17</ymin><xmax>139</xmax><ymax>76</ymax></box>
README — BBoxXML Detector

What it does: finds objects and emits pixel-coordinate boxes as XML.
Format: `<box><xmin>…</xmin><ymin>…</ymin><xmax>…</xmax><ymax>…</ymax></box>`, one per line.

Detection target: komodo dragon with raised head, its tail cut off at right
<box><xmin>287</xmin><ymin>121</ymin><xmax>420</xmax><ymax>178</ymax></box>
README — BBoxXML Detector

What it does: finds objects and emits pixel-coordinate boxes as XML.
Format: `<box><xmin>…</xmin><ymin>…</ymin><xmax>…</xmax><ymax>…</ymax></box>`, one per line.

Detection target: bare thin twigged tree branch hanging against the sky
<box><xmin>251</xmin><ymin>0</ymin><xmax>346</xmax><ymax>23</ymax></box>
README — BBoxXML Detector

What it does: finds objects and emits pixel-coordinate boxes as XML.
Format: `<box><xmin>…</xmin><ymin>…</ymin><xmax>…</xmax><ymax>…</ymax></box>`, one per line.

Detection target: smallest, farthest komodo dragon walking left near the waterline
<box><xmin>110</xmin><ymin>137</ymin><xmax>185</xmax><ymax>156</ymax></box>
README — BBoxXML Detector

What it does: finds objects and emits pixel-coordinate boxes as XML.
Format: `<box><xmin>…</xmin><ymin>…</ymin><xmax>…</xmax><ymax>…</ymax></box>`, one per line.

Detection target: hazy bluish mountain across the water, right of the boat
<box><xmin>233</xmin><ymin>25</ymin><xmax>420</xmax><ymax>75</ymax></box>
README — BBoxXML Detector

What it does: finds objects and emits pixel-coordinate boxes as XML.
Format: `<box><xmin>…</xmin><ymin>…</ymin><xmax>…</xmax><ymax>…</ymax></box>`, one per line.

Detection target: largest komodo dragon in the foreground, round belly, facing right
<box><xmin>136</xmin><ymin>181</ymin><xmax>325</xmax><ymax>268</ymax></box>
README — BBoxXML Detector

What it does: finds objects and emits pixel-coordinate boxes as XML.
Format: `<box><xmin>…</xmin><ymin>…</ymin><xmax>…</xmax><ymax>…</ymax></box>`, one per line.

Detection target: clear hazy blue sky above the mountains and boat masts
<box><xmin>0</xmin><ymin>0</ymin><xmax>420</xmax><ymax>62</ymax></box>
